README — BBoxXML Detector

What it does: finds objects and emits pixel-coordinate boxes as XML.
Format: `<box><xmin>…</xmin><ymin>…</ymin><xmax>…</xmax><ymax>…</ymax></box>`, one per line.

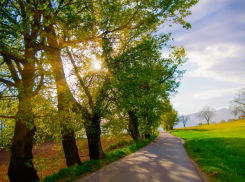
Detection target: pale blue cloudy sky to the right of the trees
<box><xmin>160</xmin><ymin>0</ymin><xmax>245</xmax><ymax>114</ymax></box>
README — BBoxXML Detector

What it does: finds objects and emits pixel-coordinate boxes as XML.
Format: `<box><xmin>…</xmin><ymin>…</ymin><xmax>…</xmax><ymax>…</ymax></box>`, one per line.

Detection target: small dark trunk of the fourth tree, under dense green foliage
<box><xmin>128</xmin><ymin>111</ymin><xmax>139</xmax><ymax>140</ymax></box>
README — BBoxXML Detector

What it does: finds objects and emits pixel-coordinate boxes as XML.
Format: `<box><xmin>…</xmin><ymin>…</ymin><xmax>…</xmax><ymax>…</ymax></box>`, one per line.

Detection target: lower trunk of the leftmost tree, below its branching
<box><xmin>8</xmin><ymin>99</ymin><xmax>39</xmax><ymax>182</ymax></box>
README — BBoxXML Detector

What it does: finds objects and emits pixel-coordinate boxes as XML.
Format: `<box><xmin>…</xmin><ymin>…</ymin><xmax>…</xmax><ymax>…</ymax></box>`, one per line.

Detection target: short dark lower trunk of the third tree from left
<box><xmin>85</xmin><ymin>114</ymin><xmax>106</xmax><ymax>160</ymax></box>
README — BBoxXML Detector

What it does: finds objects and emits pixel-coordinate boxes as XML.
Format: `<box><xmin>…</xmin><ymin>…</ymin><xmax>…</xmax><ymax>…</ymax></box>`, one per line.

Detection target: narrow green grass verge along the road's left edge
<box><xmin>43</xmin><ymin>132</ymin><xmax>158</xmax><ymax>182</ymax></box>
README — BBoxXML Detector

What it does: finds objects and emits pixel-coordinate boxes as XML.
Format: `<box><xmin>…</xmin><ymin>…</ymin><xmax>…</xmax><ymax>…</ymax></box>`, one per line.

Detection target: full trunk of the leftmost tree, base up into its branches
<box><xmin>5</xmin><ymin>46</ymin><xmax>39</xmax><ymax>182</ymax></box>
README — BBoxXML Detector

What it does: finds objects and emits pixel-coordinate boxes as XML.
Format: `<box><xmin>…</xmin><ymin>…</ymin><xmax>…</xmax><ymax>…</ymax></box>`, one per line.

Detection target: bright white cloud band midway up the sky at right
<box><xmin>185</xmin><ymin>44</ymin><xmax>245</xmax><ymax>84</ymax></box>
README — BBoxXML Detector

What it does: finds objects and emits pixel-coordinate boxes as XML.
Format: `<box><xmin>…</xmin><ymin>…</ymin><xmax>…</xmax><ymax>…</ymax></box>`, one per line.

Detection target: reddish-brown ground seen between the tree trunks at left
<box><xmin>0</xmin><ymin>136</ymin><xmax>130</xmax><ymax>182</ymax></box>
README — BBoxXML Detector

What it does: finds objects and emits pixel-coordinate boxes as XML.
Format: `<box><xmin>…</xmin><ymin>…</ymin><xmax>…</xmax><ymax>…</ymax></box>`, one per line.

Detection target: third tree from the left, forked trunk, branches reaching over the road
<box><xmin>64</xmin><ymin>1</ymin><xmax>197</xmax><ymax>155</ymax></box>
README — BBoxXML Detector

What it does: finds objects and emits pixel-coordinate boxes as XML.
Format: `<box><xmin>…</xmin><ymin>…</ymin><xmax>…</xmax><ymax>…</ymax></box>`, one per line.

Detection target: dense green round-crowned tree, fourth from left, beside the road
<box><xmin>107</xmin><ymin>35</ymin><xmax>185</xmax><ymax>140</ymax></box>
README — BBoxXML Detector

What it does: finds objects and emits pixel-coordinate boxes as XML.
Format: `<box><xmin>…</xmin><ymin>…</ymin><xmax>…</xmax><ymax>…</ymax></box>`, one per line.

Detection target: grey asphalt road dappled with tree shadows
<box><xmin>77</xmin><ymin>131</ymin><xmax>202</xmax><ymax>182</ymax></box>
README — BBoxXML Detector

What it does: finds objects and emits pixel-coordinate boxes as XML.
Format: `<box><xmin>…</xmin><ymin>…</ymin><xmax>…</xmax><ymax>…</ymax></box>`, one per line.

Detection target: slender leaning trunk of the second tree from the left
<box><xmin>46</xmin><ymin>26</ymin><xmax>81</xmax><ymax>166</ymax></box>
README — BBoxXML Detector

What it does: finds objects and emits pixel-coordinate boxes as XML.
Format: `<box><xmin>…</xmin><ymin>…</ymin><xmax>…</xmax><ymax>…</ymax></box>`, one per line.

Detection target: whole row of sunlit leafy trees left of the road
<box><xmin>0</xmin><ymin>0</ymin><xmax>197</xmax><ymax>181</ymax></box>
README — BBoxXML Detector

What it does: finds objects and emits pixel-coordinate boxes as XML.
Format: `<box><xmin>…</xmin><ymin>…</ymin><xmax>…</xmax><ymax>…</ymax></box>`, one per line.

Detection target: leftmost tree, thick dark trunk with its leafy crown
<box><xmin>0</xmin><ymin>1</ymin><xmax>47</xmax><ymax>181</ymax></box>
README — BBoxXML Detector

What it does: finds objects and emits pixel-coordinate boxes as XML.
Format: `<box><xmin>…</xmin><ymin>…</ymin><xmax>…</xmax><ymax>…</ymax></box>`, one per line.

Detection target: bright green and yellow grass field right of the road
<box><xmin>171</xmin><ymin>120</ymin><xmax>245</xmax><ymax>182</ymax></box>
